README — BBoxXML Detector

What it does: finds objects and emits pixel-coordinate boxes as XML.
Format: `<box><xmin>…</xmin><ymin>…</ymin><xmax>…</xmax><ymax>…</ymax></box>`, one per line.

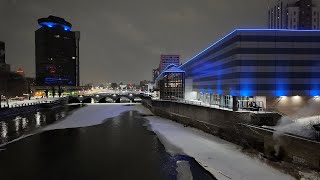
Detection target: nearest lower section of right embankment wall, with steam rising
<box><xmin>238</xmin><ymin>124</ymin><xmax>320</xmax><ymax>169</ymax></box>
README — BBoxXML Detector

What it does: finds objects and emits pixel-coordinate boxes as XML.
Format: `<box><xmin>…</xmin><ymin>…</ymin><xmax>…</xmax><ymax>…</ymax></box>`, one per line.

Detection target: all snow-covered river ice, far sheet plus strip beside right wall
<box><xmin>1</xmin><ymin>104</ymin><xmax>302</xmax><ymax>180</ymax></box>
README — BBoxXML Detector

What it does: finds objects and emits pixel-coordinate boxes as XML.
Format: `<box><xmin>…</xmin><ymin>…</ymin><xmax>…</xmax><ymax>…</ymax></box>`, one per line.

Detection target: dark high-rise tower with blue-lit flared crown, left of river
<box><xmin>35</xmin><ymin>16</ymin><xmax>80</xmax><ymax>86</ymax></box>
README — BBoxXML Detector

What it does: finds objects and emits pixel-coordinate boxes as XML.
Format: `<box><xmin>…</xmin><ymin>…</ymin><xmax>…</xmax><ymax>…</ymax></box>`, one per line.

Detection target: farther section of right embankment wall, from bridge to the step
<box><xmin>143</xmin><ymin>98</ymin><xmax>280</xmax><ymax>146</ymax></box>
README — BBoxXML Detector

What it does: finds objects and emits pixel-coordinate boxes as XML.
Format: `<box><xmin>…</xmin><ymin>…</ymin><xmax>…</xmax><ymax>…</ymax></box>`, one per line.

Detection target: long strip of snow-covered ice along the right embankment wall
<box><xmin>147</xmin><ymin>116</ymin><xmax>294</xmax><ymax>180</ymax></box>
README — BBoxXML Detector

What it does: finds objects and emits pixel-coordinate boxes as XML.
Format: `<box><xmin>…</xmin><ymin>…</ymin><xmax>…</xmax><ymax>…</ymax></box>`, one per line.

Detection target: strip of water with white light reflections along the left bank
<box><xmin>0</xmin><ymin>105</ymin><xmax>80</xmax><ymax>144</ymax></box>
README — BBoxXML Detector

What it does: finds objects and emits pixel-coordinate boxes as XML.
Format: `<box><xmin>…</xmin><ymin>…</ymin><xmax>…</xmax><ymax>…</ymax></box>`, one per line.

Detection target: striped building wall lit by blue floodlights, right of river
<box><xmin>180</xmin><ymin>29</ymin><xmax>320</xmax><ymax>96</ymax></box>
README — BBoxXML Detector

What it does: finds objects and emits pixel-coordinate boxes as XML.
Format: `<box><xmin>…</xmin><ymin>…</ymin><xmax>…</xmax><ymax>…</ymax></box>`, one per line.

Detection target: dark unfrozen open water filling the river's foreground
<box><xmin>0</xmin><ymin>111</ymin><xmax>214</xmax><ymax>180</ymax></box>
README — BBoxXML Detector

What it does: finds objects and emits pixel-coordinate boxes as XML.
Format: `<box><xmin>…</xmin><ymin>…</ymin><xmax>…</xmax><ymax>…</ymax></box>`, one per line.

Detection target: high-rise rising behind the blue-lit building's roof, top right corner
<box><xmin>268</xmin><ymin>0</ymin><xmax>320</xmax><ymax>29</ymax></box>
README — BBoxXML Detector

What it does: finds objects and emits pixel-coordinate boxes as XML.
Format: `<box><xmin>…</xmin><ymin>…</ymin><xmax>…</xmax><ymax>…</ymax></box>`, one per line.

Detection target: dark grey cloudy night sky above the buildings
<box><xmin>0</xmin><ymin>0</ymin><xmax>267</xmax><ymax>83</ymax></box>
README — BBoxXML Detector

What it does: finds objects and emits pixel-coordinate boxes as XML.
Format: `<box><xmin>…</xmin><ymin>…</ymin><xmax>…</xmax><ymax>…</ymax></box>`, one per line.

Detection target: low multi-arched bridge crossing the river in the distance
<box><xmin>68</xmin><ymin>93</ymin><xmax>144</xmax><ymax>104</ymax></box>
